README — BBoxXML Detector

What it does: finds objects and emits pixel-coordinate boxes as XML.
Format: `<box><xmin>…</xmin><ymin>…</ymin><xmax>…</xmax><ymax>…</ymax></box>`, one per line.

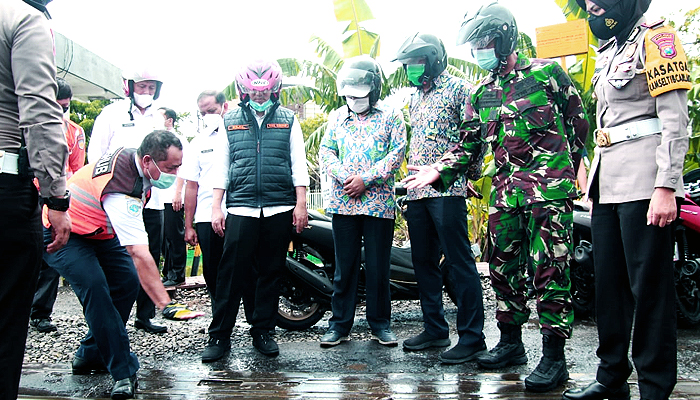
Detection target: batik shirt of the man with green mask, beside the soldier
<box><xmin>406</xmin><ymin>71</ymin><xmax>469</xmax><ymax>200</ymax></box>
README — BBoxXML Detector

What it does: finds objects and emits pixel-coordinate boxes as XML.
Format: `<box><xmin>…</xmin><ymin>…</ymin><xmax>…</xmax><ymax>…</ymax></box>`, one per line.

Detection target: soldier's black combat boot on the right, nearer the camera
<box><xmin>525</xmin><ymin>334</ymin><xmax>569</xmax><ymax>392</ymax></box>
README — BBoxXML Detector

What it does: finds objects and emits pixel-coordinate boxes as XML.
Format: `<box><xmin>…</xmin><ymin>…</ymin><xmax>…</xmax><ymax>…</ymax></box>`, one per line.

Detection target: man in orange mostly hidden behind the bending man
<box><xmin>30</xmin><ymin>78</ymin><xmax>85</xmax><ymax>333</ymax></box>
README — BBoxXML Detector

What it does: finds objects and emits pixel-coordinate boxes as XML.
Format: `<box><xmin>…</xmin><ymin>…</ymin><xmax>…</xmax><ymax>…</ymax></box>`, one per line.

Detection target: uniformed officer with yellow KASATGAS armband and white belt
<box><xmin>564</xmin><ymin>0</ymin><xmax>691</xmax><ymax>400</ymax></box>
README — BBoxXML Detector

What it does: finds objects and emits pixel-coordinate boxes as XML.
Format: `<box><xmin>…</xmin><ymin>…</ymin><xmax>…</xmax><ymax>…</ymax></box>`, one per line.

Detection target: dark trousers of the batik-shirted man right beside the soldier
<box><xmin>406</xmin><ymin>197</ymin><xmax>484</xmax><ymax>346</ymax></box>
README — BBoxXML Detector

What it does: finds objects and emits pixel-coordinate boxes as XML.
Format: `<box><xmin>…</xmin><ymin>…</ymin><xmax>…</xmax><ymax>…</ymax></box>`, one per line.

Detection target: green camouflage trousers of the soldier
<box><xmin>489</xmin><ymin>199</ymin><xmax>574</xmax><ymax>338</ymax></box>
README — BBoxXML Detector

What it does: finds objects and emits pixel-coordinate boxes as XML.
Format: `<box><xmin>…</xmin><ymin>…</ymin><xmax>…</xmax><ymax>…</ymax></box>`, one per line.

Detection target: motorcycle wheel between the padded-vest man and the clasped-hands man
<box><xmin>277</xmin><ymin>260</ymin><xmax>328</xmax><ymax>331</ymax></box>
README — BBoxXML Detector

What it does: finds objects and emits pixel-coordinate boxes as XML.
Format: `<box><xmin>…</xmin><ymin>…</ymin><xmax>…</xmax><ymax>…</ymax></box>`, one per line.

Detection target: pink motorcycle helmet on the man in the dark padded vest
<box><xmin>236</xmin><ymin>60</ymin><xmax>282</xmax><ymax>102</ymax></box>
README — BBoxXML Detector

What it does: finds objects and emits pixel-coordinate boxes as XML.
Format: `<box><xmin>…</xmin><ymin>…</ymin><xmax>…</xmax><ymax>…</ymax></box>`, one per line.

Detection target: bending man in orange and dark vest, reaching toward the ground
<box><xmin>44</xmin><ymin>130</ymin><xmax>203</xmax><ymax>399</ymax></box>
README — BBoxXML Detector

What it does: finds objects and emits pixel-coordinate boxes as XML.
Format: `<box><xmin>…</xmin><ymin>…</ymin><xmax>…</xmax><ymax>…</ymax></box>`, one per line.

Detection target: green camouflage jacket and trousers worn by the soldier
<box><xmin>436</xmin><ymin>55</ymin><xmax>588</xmax><ymax>337</ymax></box>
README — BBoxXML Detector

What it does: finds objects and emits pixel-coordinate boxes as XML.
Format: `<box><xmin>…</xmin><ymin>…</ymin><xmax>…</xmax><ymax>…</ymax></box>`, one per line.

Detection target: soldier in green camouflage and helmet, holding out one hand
<box><xmin>407</xmin><ymin>3</ymin><xmax>588</xmax><ymax>392</ymax></box>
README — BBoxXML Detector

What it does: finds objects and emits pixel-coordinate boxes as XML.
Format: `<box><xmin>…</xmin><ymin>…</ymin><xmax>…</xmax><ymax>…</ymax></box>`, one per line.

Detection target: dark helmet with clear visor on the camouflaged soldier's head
<box><xmin>457</xmin><ymin>3</ymin><xmax>518</xmax><ymax>62</ymax></box>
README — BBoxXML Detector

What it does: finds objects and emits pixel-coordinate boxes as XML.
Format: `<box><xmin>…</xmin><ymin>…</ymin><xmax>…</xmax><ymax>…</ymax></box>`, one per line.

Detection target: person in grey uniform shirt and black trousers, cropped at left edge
<box><xmin>0</xmin><ymin>0</ymin><xmax>70</xmax><ymax>400</ymax></box>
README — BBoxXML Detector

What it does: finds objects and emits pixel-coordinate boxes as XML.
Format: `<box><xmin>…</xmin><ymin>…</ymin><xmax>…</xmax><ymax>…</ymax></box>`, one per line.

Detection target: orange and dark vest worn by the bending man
<box><xmin>44</xmin><ymin>148</ymin><xmax>143</xmax><ymax>240</ymax></box>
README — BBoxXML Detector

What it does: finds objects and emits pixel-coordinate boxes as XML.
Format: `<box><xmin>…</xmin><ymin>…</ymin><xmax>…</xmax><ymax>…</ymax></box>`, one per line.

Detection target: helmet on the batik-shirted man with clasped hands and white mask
<box><xmin>336</xmin><ymin>55</ymin><xmax>382</xmax><ymax>106</ymax></box>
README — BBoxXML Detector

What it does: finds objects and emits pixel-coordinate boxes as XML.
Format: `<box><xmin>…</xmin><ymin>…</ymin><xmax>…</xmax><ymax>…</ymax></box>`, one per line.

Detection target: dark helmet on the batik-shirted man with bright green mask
<box><xmin>391</xmin><ymin>32</ymin><xmax>447</xmax><ymax>84</ymax></box>
